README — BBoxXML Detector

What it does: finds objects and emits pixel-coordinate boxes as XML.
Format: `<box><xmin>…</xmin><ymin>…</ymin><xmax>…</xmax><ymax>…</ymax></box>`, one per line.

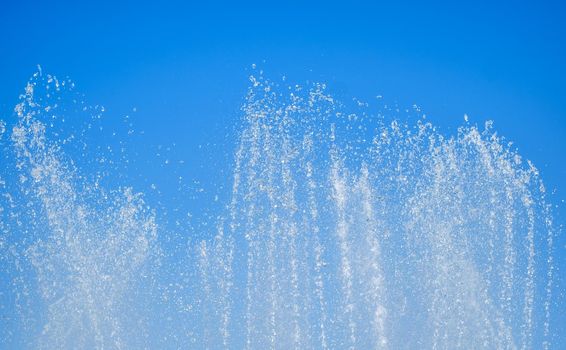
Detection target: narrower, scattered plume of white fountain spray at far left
<box><xmin>2</xmin><ymin>73</ymin><xmax>157</xmax><ymax>349</ymax></box>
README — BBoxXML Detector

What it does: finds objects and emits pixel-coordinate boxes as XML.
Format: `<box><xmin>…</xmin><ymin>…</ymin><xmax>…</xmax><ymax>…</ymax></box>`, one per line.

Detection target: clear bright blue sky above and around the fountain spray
<box><xmin>0</xmin><ymin>0</ymin><xmax>566</xmax><ymax>347</ymax></box>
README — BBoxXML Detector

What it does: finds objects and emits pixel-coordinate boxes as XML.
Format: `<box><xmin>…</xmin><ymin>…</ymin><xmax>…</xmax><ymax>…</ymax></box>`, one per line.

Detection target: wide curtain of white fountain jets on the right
<box><xmin>191</xmin><ymin>72</ymin><xmax>552</xmax><ymax>349</ymax></box>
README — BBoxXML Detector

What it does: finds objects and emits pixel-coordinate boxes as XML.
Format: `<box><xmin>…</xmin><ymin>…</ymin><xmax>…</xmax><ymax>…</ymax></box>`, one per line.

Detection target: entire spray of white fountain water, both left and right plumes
<box><xmin>0</xmin><ymin>74</ymin><xmax>553</xmax><ymax>349</ymax></box>
